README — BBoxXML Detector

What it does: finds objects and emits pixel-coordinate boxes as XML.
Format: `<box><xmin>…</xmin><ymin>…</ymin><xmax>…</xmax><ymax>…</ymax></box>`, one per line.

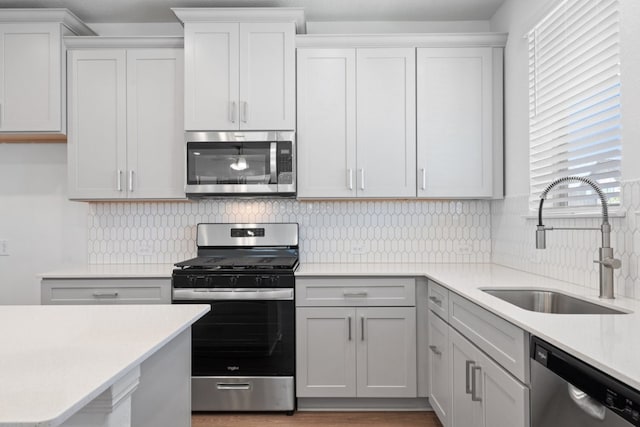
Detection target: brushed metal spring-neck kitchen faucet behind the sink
<box><xmin>536</xmin><ymin>176</ymin><xmax>621</xmax><ymax>299</ymax></box>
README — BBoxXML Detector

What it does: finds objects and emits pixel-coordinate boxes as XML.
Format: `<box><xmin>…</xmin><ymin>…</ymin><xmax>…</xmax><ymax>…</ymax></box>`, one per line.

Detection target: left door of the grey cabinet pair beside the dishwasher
<box><xmin>449</xmin><ymin>328</ymin><xmax>482</xmax><ymax>427</ymax></box>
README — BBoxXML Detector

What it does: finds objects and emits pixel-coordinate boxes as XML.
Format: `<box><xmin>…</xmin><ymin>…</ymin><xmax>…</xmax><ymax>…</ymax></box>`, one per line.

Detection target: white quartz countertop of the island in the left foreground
<box><xmin>0</xmin><ymin>304</ymin><xmax>210</xmax><ymax>426</ymax></box>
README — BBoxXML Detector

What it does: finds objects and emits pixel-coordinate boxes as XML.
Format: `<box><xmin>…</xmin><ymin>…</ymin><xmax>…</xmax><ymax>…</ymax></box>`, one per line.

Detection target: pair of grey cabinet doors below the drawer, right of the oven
<box><xmin>296</xmin><ymin>307</ymin><xmax>417</xmax><ymax>397</ymax></box>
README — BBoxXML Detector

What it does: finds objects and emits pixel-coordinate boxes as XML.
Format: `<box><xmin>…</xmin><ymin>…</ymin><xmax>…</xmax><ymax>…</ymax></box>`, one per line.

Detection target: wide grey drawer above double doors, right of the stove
<box><xmin>296</xmin><ymin>277</ymin><xmax>416</xmax><ymax>307</ymax></box>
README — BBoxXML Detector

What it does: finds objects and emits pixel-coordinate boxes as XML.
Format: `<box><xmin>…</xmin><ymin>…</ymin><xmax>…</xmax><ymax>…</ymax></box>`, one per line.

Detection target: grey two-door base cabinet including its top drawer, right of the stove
<box><xmin>296</xmin><ymin>277</ymin><xmax>418</xmax><ymax>398</ymax></box>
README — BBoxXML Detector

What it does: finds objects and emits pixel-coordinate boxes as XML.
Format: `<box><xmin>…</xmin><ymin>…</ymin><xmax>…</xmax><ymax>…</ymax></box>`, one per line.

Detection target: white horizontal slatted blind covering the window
<box><xmin>528</xmin><ymin>0</ymin><xmax>622</xmax><ymax>211</ymax></box>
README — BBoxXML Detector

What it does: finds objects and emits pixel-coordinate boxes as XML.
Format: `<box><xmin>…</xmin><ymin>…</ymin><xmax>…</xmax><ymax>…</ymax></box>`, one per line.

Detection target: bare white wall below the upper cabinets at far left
<box><xmin>0</xmin><ymin>143</ymin><xmax>88</xmax><ymax>304</ymax></box>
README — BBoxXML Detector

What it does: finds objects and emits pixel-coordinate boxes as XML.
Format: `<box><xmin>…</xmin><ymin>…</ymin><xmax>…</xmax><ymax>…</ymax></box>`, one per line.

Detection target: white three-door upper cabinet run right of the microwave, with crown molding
<box><xmin>296</xmin><ymin>34</ymin><xmax>506</xmax><ymax>199</ymax></box>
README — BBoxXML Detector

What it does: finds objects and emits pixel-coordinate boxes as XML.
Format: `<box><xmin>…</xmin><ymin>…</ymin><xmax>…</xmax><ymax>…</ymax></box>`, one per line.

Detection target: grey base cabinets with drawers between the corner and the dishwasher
<box><xmin>428</xmin><ymin>282</ymin><xmax>529</xmax><ymax>427</ymax></box>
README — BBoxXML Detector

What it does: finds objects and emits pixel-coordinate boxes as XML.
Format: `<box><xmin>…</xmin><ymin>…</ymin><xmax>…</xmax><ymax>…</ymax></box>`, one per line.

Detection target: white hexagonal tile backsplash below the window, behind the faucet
<box><xmin>491</xmin><ymin>181</ymin><xmax>640</xmax><ymax>298</ymax></box>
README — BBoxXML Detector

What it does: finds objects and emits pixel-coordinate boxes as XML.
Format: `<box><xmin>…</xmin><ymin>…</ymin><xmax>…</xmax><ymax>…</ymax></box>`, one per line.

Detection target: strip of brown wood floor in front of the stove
<box><xmin>191</xmin><ymin>412</ymin><xmax>442</xmax><ymax>427</ymax></box>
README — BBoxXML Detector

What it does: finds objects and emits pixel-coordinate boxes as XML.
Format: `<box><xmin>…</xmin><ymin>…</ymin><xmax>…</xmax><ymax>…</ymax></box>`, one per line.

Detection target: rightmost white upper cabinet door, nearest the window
<box><xmin>417</xmin><ymin>47</ymin><xmax>501</xmax><ymax>197</ymax></box>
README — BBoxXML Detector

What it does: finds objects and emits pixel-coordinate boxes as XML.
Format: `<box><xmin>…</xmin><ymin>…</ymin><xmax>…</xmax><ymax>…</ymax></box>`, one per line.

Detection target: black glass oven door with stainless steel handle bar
<box><xmin>173</xmin><ymin>288</ymin><xmax>295</xmax><ymax>377</ymax></box>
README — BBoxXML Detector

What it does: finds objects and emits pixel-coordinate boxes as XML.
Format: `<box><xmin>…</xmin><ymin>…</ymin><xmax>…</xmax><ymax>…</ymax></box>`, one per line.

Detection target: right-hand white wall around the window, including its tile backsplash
<box><xmin>491</xmin><ymin>0</ymin><xmax>640</xmax><ymax>298</ymax></box>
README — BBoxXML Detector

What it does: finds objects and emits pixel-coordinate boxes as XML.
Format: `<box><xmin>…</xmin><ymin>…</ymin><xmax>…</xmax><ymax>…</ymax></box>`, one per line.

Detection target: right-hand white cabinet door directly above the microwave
<box><xmin>239</xmin><ymin>23</ymin><xmax>296</xmax><ymax>130</ymax></box>
